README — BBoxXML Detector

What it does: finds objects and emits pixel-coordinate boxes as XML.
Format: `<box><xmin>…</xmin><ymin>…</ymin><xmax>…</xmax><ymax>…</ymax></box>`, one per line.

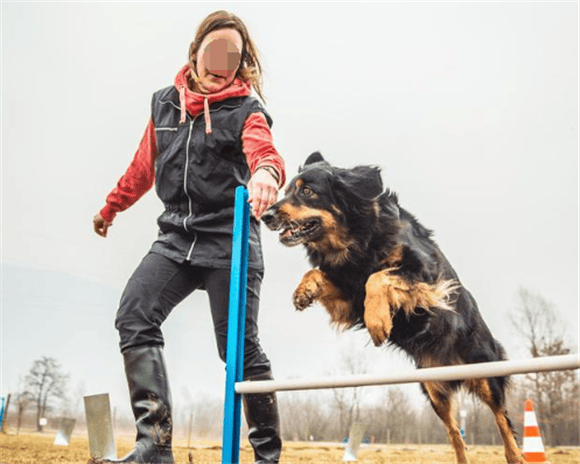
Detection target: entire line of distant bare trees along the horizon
<box><xmin>9</xmin><ymin>288</ymin><xmax>580</xmax><ymax>446</ymax></box>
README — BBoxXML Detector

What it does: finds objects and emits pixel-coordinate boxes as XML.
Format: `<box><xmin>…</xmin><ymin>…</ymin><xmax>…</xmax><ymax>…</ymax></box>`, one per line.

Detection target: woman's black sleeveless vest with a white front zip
<box><xmin>146</xmin><ymin>86</ymin><xmax>272</xmax><ymax>270</ymax></box>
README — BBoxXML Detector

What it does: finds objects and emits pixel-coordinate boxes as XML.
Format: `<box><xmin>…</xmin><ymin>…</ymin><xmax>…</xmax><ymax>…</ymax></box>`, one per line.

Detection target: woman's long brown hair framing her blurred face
<box><xmin>189</xmin><ymin>10</ymin><xmax>265</xmax><ymax>101</ymax></box>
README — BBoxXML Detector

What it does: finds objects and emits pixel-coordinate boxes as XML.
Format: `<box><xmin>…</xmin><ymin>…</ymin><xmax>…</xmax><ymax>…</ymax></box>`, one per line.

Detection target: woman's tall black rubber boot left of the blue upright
<box><xmin>93</xmin><ymin>346</ymin><xmax>175</xmax><ymax>464</ymax></box>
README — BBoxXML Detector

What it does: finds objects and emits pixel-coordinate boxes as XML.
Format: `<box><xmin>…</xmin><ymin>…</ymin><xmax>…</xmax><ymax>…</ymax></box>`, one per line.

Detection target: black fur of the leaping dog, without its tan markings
<box><xmin>263</xmin><ymin>152</ymin><xmax>507</xmax><ymax>404</ymax></box>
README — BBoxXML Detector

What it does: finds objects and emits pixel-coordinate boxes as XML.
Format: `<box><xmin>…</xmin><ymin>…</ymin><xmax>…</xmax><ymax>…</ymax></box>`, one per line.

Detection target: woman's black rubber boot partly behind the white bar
<box><xmin>242</xmin><ymin>372</ymin><xmax>282</xmax><ymax>464</ymax></box>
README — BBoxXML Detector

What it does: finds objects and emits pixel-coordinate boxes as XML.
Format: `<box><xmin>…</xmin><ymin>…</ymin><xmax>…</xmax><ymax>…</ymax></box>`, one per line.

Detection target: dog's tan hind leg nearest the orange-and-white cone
<box><xmin>466</xmin><ymin>378</ymin><xmax>525</xmax><ymax>464</ymax></box>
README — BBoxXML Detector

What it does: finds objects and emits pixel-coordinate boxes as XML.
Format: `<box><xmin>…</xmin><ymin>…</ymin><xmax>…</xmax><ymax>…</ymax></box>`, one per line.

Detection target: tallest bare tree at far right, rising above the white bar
<box><xmin>511</xmin><ymin>288</ymin><xmax>578</xmax><ymax>446</ymax></box>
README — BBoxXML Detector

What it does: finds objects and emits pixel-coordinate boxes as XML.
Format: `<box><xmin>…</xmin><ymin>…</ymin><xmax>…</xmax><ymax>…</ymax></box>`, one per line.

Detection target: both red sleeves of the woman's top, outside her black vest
<box><xmin>100</xmin><ymin>112</ymin><xmax>286</xmax><ymax>222</ymax></box>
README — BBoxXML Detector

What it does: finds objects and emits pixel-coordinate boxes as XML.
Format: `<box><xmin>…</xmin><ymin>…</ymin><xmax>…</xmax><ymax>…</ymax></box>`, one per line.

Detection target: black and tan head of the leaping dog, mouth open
<box><xmin>262</xmin><ymin>152</ymin><xmax>383</xmax><ymax>250</ymax></box>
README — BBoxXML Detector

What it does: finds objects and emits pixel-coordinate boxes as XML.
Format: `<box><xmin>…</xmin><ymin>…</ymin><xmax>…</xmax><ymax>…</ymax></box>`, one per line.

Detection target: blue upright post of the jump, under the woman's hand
<box><xmin>222</xmin><ymin>186</ymin><xmax>250</xmax><ymax>464</ymax></box>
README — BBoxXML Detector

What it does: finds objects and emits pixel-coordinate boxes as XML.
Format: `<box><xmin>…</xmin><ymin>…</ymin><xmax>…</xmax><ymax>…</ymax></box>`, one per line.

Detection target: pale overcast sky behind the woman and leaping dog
<box><xmin>1</xmin><ymin>2</ymin><xmax>578</xmax><ymax>424</ymax></box>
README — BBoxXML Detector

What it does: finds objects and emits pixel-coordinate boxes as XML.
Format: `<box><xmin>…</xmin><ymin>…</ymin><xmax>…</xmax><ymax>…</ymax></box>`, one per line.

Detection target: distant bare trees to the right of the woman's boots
<box><xmin>274</xmin><ymin>288</ymin><xmax>580</xmax><ymax>446</ymax></box>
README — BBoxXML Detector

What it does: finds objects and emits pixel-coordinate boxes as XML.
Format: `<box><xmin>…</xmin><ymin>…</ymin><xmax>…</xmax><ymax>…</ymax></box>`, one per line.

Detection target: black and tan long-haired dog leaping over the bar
<box><xmin>262</xmin><ymin>152</ymin><xmax>524</xmax><ymax>463</ymax></box>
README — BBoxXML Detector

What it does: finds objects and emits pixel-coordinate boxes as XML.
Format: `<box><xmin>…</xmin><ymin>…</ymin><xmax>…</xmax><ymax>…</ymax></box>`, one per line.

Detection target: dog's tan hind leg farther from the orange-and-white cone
<box><xmin>422</xmin><ymin>382</ymin><xmax>469</xmax><ymax>464</ymax></box>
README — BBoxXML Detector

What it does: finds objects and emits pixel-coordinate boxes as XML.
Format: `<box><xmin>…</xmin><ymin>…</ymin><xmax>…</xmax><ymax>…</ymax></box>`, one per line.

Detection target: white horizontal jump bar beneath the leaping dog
<box><xmin>235</xmin><ymin>354</ymin><xmax>580</xmax><ymax>393</ymax></box>
